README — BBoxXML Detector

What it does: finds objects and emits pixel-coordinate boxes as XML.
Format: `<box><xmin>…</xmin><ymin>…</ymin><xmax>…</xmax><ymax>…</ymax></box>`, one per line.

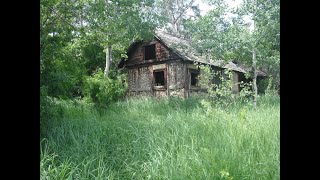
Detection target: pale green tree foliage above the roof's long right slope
<box><xmin>184</xmin><ymin>0</ymin><xmax>280</xmax><ymax>92</ymax></box>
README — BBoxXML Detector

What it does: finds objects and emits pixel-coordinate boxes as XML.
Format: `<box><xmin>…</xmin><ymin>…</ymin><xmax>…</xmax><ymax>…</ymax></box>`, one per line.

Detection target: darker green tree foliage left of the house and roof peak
<box><xmin>40</xmin><ymin>0</ymin><xmax>156</xmax><ymax>99</ymax></box>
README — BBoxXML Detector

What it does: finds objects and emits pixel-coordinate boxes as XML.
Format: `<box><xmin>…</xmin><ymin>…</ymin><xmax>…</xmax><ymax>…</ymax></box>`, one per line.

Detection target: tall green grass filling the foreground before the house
<box><xmin>40</xmin><ymin>96</ymin><xmax>280</xmax><ymax>179</ymax></box>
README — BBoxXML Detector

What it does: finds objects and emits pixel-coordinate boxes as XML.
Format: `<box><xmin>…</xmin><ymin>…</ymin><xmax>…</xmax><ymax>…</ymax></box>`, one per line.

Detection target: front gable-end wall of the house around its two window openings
<box><xmin>125</xmin><ymin>40</ymin><xmax>186</xmax><ymax>97</ymax></box>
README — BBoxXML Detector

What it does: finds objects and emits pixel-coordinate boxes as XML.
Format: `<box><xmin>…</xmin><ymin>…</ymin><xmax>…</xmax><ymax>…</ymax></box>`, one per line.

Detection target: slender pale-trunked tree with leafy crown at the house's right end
<box><xmin>237</xmin><ymin>0</ymin><xmax>280</xmax><ymax>107</ymax></box>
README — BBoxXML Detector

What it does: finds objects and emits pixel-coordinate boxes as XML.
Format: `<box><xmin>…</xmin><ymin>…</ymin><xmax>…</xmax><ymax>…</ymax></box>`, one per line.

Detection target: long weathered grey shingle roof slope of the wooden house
<box><xmin>154</xmin><ymin>31</ymin><xmax>266</xmax><ymax>76</ymax></box>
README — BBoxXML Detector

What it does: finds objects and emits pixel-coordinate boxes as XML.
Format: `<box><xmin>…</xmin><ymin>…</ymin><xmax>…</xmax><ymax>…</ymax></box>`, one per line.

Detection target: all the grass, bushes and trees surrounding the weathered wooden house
<box><xmin>40</xmin><ymin>0</ymin><xmax>280</xmax><ymax>179</ymax></box>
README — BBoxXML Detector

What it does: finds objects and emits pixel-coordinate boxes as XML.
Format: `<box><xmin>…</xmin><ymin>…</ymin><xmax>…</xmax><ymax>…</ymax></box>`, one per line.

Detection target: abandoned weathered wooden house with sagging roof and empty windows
<box><xmin>118</xmin><ymin>31</ymin><xmax>265</xmax><ymax>98</ymax></box>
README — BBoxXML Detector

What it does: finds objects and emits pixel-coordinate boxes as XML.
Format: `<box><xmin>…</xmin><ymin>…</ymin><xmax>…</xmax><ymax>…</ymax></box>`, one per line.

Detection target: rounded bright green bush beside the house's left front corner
<box><xmin>84</xmin><ymin>69</ymin><xmax>127</xmax><ymax>107</ymax></box>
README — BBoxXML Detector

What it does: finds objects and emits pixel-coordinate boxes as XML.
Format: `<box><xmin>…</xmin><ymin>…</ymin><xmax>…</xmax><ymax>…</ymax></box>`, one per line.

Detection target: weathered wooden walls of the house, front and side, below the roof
<box><xmin>122</xmin><ymin>38</ymin><xmax>258</xmax><ymax>98</ymax></box>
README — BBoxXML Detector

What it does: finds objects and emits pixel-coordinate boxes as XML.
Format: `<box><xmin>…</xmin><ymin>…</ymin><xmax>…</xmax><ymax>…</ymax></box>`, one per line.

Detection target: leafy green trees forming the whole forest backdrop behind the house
<box><xmin>40</xmin><ymin>0</ymin><xmax>280</xmax><ymax>99</ymax></box>
